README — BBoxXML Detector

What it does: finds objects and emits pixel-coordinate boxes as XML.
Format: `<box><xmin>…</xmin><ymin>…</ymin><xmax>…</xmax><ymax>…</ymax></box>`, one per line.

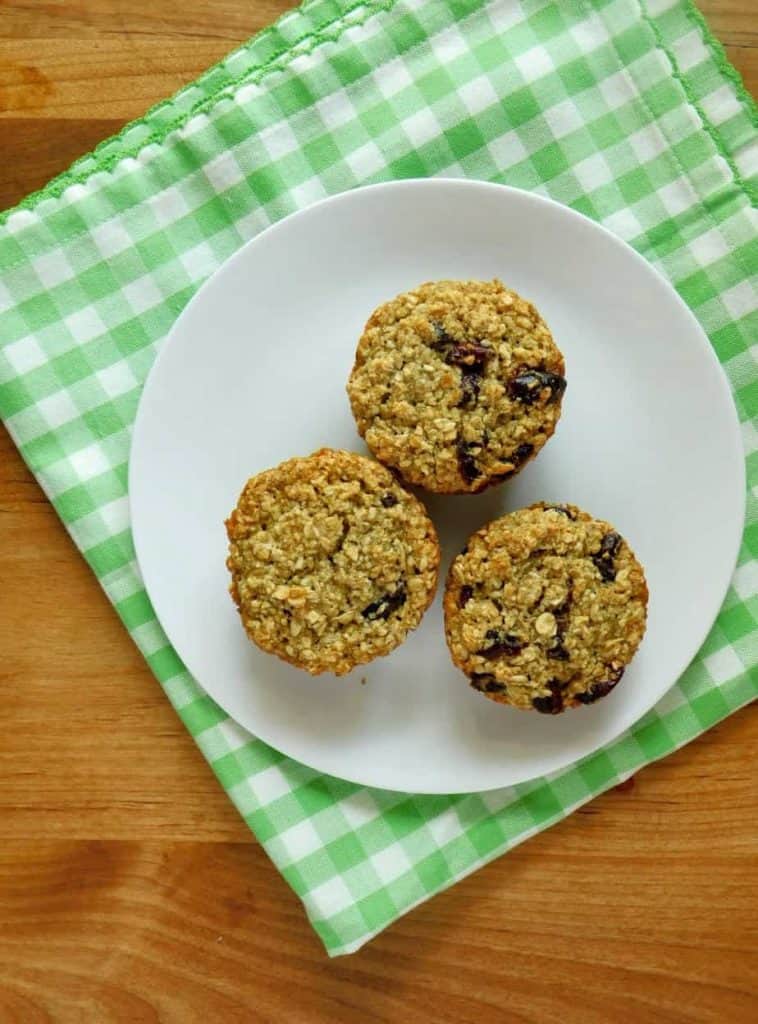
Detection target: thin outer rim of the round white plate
<box><xmin>127</xmin><ymin>176</ymin><xmax>746</xmax><ymax>795</ymax></box>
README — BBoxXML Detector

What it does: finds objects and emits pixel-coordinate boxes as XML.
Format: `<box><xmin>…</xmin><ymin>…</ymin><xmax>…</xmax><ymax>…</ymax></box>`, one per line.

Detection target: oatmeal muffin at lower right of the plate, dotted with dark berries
<box><xmin>445</xmin><ymin>504</ymin><xmax>647</xmax><ymax>715</ymax></box>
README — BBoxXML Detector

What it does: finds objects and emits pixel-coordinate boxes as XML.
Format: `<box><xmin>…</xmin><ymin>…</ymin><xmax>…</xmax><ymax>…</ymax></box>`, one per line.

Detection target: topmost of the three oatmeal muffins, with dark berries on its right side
<box><xmin>347</xmin><ymin>281</ymin><xmax>565</xmax><ymax>494</ymax></box>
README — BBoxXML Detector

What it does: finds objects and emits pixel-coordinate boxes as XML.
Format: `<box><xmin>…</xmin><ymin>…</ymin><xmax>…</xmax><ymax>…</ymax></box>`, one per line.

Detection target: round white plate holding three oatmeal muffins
<box><xmin>129</xmin><ymin>179</ymin><xmax>744</xmax><ymax>793</ymax></box>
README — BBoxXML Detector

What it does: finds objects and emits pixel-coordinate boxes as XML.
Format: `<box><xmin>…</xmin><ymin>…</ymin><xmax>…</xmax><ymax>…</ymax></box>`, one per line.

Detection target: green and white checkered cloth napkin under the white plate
<box><xmin>0</xmin><ymin>0</ymin><xmax>758</xmax><ymax>955</ymax></box>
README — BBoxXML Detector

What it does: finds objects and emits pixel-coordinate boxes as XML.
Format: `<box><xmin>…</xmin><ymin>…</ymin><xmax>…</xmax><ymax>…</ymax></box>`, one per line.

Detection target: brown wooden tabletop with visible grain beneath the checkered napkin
<box><xmin>0</xmin><ymin>0</ymin><xmax>758</xmax><ymax>1024</ymax></box>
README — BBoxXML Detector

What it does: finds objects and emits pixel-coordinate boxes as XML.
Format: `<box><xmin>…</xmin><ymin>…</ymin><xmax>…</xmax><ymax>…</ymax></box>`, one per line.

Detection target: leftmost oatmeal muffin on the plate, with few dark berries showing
<box><xmin>226</xmin><ymin>449</ymin><xmax>439</xmax><ymax>676</ymax></box>
